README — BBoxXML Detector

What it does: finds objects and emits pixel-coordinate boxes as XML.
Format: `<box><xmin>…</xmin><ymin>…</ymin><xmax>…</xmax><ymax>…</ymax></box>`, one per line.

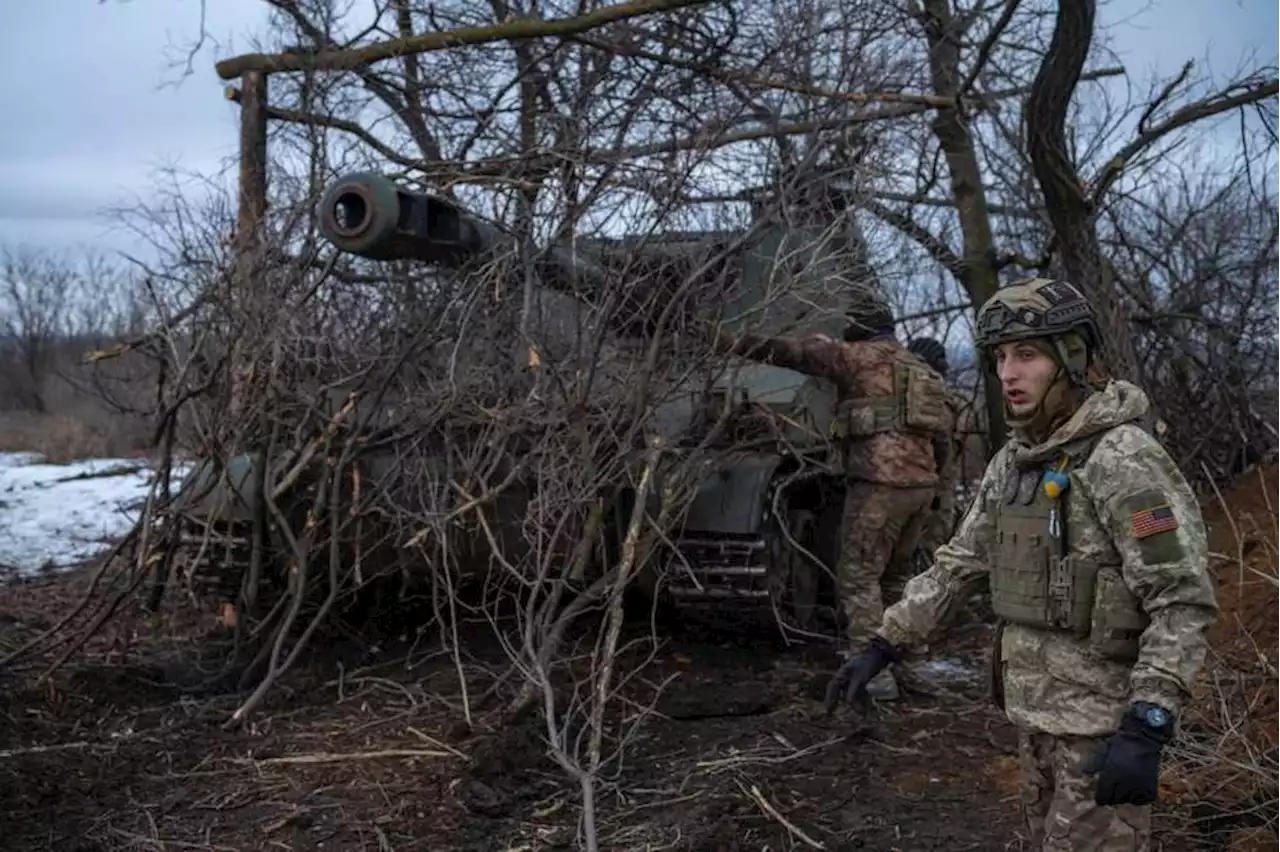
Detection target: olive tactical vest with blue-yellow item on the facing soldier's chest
<box><xmin>991</xmin><ymin>439</ymin><xmax>1149</xmax><ymax>663</ymax></box>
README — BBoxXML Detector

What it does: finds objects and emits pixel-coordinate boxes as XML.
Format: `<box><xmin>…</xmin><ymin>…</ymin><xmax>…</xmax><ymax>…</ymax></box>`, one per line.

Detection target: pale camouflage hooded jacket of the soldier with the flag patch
<box><xmin>879</xmin><ymin>381</ymin><xmax>1219</xmax><ymax>736</ymax></box>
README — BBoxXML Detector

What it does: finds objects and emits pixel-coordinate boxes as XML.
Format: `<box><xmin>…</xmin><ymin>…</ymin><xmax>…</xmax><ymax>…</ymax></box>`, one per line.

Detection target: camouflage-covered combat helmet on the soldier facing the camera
<box><xmin>974</xmin><ymin>278</ymin><xmax>1102</xmax><ymax>389</ymax></box>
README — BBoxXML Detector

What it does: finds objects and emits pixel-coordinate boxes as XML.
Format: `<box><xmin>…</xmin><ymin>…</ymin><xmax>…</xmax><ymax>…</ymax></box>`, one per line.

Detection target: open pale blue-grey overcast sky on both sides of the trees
<box><xmin>0</xmin><ymin>0</ymin><xmax>1280</xmax><ymax>258</ymax></box>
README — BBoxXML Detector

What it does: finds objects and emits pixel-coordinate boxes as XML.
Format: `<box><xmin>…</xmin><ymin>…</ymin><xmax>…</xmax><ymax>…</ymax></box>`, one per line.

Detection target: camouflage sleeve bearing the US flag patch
<box><xmin>1084</xmin><ymin>425</ymin><xmax>1219</xmax><ymax>714</ymax></box>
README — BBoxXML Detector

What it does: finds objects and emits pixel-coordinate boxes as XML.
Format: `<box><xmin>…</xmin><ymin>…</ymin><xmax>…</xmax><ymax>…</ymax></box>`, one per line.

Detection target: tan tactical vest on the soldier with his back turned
<box><xmin>831</xmin><ymin>356</ymin><xmax>947</xmax><ymax>440</ymax></box>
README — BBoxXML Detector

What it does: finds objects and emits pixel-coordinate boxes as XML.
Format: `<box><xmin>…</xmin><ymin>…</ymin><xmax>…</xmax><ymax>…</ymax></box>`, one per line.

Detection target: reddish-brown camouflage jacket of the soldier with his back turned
<box><xmin>721</xmin><ymin>334</ymin><xmax>938</xmax><ymax>487</ymax></box>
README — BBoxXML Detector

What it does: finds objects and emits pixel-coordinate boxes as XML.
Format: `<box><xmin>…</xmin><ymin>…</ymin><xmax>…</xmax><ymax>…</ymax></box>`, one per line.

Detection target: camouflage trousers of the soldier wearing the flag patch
<box><xmin>1018</xmin><ymin>730</ymin><xmax>1151</xmax><ymax>852</ymax></box>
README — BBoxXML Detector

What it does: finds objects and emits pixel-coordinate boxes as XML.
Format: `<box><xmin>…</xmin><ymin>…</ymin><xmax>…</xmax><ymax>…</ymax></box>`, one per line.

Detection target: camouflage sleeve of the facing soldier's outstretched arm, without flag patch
<box><xmin>877</xmin><ymin>444</ymin><xmax>1009</xmax><ymax>649</ymax></box>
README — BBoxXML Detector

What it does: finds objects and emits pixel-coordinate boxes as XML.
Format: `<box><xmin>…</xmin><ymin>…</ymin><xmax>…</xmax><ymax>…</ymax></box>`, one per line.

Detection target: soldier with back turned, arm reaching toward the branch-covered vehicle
<box><xmin>716</xmin><ymin>290</ymin><xmax>946</xmax><ymax>700</ymax></box>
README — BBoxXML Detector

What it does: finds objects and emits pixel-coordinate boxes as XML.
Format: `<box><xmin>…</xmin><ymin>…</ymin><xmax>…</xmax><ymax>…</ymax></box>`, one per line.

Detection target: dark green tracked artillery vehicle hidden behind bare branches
<box><xmin>172</xmin><ymin>173</ymin><xmax>868</xmax><ymax>631</ymax></box>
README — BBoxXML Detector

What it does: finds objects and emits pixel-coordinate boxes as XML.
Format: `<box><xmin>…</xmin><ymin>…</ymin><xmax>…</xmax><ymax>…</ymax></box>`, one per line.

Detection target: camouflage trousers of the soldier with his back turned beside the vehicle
<box><xmin>836</xmin><ymin>481</ymin><xmax>933</xmax><ymax>649</ymax></box>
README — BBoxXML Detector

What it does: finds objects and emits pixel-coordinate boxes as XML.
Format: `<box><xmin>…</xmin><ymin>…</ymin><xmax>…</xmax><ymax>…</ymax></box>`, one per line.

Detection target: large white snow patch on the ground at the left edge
<box><xmin>0</xmin><ymin>453</ymin><xmax>189</xmax><ymax>574</ymax></box>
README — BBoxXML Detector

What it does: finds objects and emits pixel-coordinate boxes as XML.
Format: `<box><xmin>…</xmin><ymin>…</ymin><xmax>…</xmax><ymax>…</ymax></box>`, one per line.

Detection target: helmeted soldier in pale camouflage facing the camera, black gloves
<box><xmin>827</xmin><ymin>279</ymin><xmax>1219</xmax><ymax>852</ymax></box>
